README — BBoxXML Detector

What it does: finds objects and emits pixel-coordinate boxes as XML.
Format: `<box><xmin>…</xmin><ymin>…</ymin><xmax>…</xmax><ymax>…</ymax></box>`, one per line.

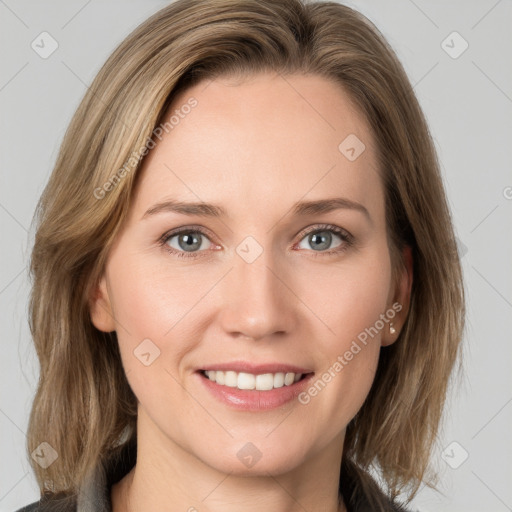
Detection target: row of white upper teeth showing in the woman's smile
<box><xmin>204</xmin><ymin>370</ymin><xmax>302</xmax><ymax>391</ymax></box>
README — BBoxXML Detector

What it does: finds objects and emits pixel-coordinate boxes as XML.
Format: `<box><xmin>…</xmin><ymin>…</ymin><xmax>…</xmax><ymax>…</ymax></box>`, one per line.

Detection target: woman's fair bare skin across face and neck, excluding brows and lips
<box><xmin>91</xmin><ymin>74</ymin><xmax>412</xmax><ymax>512</ymax></box>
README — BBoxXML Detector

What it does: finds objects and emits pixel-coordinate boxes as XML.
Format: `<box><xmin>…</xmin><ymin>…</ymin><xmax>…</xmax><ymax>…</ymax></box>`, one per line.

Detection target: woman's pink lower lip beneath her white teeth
<box><xmin>197</xmin><ymin>372</ymin><xmax>313</xmax><ymax>412</ymax></box>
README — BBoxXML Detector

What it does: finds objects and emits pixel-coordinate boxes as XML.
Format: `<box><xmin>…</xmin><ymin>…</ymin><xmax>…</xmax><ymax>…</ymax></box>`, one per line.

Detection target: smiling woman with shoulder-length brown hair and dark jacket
<box><xmin>17</xmin><ymin>0</ymin><xmax>464</xmax><ymax>512</ymax></box>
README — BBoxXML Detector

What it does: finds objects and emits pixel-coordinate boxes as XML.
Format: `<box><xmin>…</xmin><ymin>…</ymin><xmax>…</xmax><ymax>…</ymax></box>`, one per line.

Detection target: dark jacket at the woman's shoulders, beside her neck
<box><xmin>16</xmin><ymin>444</ymin><xmax>408</xmax><ymax>512</ymax></box>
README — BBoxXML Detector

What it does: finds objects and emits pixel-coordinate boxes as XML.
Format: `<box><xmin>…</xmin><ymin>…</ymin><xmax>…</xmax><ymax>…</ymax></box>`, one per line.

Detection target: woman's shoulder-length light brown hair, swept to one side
<box><xmin>27</xmin><ymin>0</ymin><xmax>464</xmax><ymax>508</ymax></box>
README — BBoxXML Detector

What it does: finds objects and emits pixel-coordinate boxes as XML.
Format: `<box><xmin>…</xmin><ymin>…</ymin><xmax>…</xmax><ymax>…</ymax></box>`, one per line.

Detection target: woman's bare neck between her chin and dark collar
<box><xmin>111</xmin><ymin>408</ymin><xmax>346</xmax><ymax>512</ymax></box>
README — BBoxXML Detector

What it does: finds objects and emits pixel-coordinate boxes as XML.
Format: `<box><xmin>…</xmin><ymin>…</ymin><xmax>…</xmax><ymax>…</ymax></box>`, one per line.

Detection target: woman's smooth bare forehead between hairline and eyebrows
<box><xmin>130</xmin><ymin>74</ymin><xmax>382</xmax><ymax>222</ymax></box>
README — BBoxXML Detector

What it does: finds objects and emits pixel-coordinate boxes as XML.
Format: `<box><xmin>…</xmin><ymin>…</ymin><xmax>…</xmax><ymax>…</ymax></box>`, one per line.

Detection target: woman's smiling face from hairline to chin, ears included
<box><xmin>91</xmin><ymin>74</ymin><xmax>407</xmax><ymax>474</ymax></box>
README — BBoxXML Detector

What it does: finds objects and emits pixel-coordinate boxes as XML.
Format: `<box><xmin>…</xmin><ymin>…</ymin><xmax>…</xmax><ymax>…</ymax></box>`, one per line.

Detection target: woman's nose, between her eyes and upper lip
<box><xmin>220</xmin><ymin>242</ymin><xmax>300</xmax><ymax>340</ymax></box>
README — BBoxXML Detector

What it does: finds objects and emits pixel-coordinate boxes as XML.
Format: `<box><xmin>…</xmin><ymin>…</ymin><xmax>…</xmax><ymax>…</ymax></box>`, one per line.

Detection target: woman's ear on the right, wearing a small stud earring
<box><xmin>381</xmin><ymin>246</ymin><xmax>413</xmax><ymax>347</ymax></box>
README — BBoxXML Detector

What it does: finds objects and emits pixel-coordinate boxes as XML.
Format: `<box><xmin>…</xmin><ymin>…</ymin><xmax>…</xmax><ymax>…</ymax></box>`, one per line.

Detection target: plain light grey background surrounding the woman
<box><xmin>0</xmin><ymin>0</ymin><xmax>512</xmax><ymax>512</ymax></box>
